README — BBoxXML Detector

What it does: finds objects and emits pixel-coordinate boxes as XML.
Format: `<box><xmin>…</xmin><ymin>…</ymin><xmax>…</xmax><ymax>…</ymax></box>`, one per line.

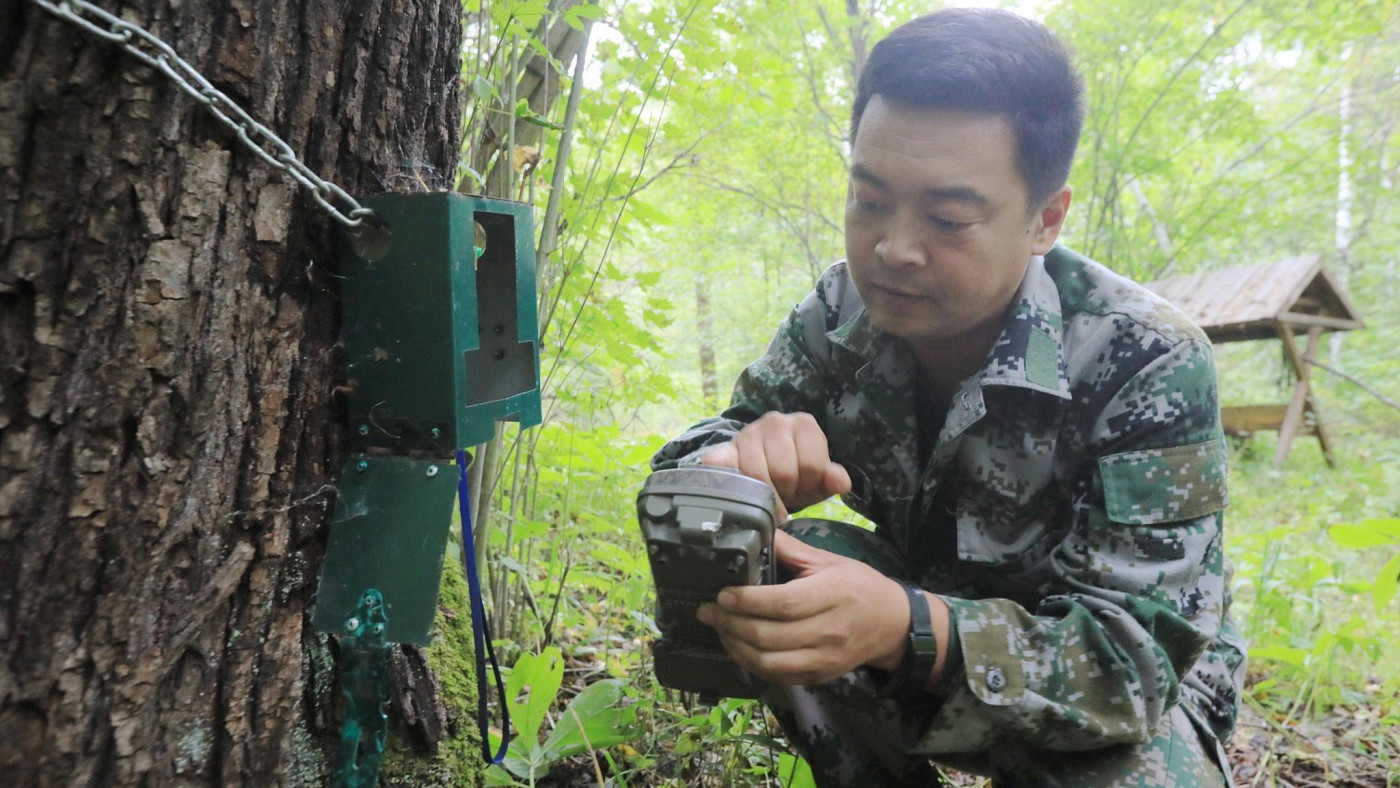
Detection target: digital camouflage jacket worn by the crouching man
<box><xmin>652</xmin><ymin>246</ymin><xmax>1245</xmax><ymax>756</ymax></box>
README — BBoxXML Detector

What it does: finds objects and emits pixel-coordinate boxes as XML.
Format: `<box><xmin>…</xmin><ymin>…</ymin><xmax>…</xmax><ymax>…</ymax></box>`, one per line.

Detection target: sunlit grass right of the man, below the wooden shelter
<box><xmin>1226</xmin><ymin>432</ymin><xmax>1400</xmax><ymax>785</ymax></box>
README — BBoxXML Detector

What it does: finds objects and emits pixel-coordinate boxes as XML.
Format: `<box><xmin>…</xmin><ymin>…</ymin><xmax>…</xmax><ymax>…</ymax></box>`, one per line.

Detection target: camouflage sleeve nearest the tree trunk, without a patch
<box><xmin>651</xmin><ymin>263</ymin><xmax>850</xmax><ymax>470</ymax></box>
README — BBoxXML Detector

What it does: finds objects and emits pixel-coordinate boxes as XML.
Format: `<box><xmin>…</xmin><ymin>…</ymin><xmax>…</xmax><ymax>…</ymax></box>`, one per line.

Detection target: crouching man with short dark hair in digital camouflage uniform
<box><xmin>652</xmin><ymin>8</ymin><xmax>1243</xmax><ymax>787</ymax></box>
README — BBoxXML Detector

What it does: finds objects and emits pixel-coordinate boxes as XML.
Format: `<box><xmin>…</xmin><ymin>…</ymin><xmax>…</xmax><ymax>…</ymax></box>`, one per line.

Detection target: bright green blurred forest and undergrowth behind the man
<box><xmin>411</xmin><ymin>0</ymin><xmax>1400</xmax><ymax>785</ymax></box>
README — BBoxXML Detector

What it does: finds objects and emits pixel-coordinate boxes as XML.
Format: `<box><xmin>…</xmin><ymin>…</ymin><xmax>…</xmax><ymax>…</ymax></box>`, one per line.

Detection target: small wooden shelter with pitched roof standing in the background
<box><xmin>1147</xmin><ymin>255</ymin><xmax>1364</xmax><ymax>465</ymax></box>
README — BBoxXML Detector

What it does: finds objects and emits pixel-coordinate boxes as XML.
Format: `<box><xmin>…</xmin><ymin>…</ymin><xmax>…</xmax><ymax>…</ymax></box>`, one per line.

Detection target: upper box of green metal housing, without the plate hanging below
<box><xmin>340</xmin><ymin>192</ymin><xmax>540</xmax><ymax>455</ymax></box>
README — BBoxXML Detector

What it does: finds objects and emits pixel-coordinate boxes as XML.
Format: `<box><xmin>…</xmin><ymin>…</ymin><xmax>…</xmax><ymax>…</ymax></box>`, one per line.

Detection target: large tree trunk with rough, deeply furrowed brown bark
<box><xmin>0</xmin><ymin>0</ymin><xmax>476</xmax><ymax>787</ymax></box>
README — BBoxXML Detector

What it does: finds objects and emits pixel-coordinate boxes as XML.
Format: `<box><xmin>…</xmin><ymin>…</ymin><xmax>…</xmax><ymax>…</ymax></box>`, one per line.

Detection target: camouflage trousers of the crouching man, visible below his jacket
<box><xmin>763</xmin><ymin>519</ymin><xmax>1228</xmax><ymax>788</ymax></box>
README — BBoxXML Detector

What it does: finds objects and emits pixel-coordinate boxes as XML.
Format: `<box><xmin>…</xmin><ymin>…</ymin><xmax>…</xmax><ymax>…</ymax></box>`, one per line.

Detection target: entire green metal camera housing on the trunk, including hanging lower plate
<box><xmin>312</xmin><ymin>193</ymin><xmax>540</xmax><ymax>644</ymax></box>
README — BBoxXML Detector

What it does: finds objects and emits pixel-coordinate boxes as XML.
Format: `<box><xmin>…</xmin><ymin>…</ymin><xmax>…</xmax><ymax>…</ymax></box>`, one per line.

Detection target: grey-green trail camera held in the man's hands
<box><xmin>637</xmin><ymin>466</ymin><xmax>778</xmax><ymax>698</ymax></box>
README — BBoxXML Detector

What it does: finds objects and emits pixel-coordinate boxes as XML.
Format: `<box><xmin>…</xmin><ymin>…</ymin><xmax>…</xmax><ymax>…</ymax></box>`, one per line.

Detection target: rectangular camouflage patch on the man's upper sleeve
<box><xmin>1099</xmin><ymin>438</ymin><xmax>1229</xmax><ymax>525</ymax></box>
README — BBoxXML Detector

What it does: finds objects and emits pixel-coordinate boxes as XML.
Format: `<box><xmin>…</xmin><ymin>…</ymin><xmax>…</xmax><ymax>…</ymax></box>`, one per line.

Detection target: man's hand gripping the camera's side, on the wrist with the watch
<box><xmin>699</xmin><ymin>530</ymin><xmax>909</xmax><ymax>684</ymax></box>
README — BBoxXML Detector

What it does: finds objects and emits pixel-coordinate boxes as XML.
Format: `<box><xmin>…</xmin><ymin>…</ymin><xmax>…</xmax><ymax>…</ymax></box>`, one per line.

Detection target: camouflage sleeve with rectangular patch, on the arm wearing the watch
<box><xmin>917</xmin><ymin>337</ymin><xmax>1226</xmax><ymax>756</ymax></box>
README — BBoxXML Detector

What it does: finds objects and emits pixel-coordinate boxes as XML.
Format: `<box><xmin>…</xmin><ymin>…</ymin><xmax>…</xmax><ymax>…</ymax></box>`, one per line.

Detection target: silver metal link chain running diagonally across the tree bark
<box><xmin>34</xmin><ymin>0</ymin><xmax>374</xmax><ymax>228</ymax></box>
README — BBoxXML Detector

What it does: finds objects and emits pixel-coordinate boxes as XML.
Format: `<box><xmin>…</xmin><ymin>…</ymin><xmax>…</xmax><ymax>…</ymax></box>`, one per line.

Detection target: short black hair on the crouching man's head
<box><xmin>851</xmin><ymin>8</ymin><xmax>1084</xmax><ymax>209</ymax></box>
